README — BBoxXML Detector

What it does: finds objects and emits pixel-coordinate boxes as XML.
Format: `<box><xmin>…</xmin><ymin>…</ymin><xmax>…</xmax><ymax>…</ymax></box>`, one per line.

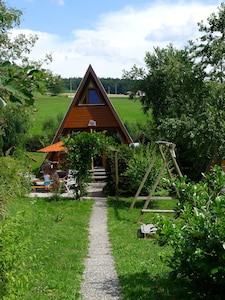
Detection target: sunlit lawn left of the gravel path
<box><xmin>5</xmin><ymin>198</ymin><xmax>93</xmax><ymax>300</ymax></box>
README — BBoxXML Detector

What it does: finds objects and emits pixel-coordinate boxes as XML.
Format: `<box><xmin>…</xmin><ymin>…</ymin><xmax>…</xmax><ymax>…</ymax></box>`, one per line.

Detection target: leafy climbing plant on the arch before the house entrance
<box><xmin>63</xmin><ymin>131</ymin><xmax>113</xmax><ymax>197</ymax></box>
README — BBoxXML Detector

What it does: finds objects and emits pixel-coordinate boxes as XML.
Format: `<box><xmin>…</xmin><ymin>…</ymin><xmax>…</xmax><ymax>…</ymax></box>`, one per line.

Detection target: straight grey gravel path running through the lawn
<box><xmin>81</xmin><ymin>197</ymin><xmax>122</xmax><ymax>300</ymax></box>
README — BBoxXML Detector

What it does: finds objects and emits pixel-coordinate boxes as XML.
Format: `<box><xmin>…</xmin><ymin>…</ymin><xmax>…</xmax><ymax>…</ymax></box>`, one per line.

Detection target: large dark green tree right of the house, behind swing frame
<box><xmin>123</xmin><ymin>4</ymin><xmax>225</xmax><ymax>180</ymax></box>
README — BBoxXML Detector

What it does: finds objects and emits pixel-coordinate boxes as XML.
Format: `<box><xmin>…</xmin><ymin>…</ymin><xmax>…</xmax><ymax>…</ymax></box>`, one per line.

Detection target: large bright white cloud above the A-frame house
<box><xmin>11</xmin><ymin>1</ymin><xmax>216</xmax><ymax>77</ymax></box>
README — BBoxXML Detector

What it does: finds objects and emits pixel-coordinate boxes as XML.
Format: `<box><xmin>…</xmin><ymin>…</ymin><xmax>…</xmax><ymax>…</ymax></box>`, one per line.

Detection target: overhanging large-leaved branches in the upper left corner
<box><xmin>0</xmin><ymin>1</ymin><xmax>51</xmax><ymax>105</ymax></box>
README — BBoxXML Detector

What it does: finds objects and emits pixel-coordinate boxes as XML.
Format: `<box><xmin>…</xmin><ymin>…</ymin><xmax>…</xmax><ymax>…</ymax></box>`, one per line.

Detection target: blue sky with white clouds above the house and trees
<box><xmin>8</xmin><ymin>0</ymin><xmax>223</xmax><ymax>78</ymax></box>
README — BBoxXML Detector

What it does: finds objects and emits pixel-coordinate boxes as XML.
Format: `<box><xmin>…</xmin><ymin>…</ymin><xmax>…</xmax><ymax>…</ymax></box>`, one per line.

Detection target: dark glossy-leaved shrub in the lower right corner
<box><xmin>155</xmin><ymin>166</ymin><xmax>225</xmax><ymax>299</ymax></box>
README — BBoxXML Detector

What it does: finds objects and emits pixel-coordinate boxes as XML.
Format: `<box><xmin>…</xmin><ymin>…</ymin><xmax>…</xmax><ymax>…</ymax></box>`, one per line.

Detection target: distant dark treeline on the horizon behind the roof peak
<box><xmin>63</xmin><ymin>77</ymin><xmax>133</xmax><ymax>94</ymax></box>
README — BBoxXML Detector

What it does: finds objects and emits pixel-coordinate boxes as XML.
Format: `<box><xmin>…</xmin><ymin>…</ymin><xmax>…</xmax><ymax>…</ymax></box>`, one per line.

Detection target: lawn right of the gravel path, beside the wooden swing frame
<box><xmin>108</xmin><ymin>197</ymin><xmax>176</xmax><ymax>300</ymax></box>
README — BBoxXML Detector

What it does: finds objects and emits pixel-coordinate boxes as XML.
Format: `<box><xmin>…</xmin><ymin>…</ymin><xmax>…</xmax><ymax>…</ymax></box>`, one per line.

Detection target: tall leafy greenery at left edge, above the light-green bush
<box><xmin>0</xmin><ymin>1</ymin><xmax>54</xmax><ymax>155</ymax></box>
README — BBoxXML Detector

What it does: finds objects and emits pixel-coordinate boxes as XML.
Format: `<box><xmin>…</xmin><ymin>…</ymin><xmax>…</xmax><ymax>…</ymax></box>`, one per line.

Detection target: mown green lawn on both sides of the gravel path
<box><xmin>3</xmin><ymin>197</ymin><xmax>179</xmax><ymax>300</ymax></box>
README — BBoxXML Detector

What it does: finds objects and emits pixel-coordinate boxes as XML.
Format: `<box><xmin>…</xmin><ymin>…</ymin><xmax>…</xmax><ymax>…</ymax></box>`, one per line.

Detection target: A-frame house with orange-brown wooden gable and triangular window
<box><xmin>46</xmin><ymin>65</ymin><xmax>132</xmax><ymax>165</ymax></box>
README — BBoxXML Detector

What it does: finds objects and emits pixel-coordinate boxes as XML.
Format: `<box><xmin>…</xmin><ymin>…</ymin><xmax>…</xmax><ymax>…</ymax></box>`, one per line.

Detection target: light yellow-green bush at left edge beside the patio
<box><xmin>0</xmin><ymin>157</ymin><xmax>30</xmax><ymax>216</ymax></box>
